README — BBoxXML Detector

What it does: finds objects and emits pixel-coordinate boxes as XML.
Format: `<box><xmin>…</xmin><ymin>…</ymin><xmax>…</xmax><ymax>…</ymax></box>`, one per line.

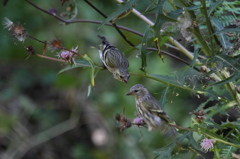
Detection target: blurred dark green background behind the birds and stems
<box><xmin>0</xmin><ymin>0</ymin><xmax>203</xmax><ymax>159</ymax></box>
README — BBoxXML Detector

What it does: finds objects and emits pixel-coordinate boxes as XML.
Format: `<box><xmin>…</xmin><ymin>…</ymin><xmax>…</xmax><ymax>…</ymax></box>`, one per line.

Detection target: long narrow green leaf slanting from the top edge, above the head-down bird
<box><xmin>98</xmin><ymin>0</ymin><xmax>136</xmax><ymax>29</ymax></box>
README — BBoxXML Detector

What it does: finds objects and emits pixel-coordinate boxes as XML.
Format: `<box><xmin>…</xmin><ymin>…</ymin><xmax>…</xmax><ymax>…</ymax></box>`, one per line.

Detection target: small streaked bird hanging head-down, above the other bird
<box><xmin>98</xmin><ymin>35</ymin><xmax>130</xmax><ymax>84</ymax></box>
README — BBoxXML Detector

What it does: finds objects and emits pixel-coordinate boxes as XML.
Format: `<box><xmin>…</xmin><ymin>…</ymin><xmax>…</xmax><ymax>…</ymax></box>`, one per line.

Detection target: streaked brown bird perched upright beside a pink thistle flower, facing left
<box><xmin>127</xmin><ymin>84</ymin><xmax>176</xmax><ymax>136</ymax></box>
